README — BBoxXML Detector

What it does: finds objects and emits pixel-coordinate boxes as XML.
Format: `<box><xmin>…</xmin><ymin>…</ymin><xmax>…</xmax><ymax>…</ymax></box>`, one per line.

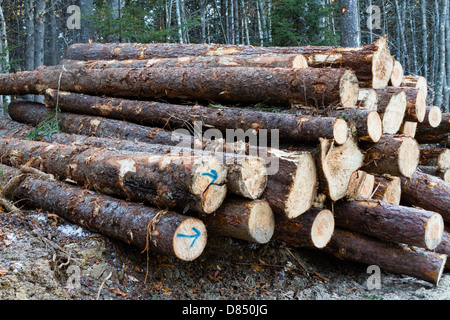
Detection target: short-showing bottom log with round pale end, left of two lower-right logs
<box><xmin>273</xmin><ymin>207</ymin><xmax>334</xmax><ymax>249</ymax></box>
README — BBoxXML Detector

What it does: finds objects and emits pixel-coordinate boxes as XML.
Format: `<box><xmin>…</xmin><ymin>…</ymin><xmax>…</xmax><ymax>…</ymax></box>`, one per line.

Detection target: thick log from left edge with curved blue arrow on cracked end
<box><xmin>0</xmin><ymin>138</ymin><xmax>227</xmax><ymax>213</ymax></box>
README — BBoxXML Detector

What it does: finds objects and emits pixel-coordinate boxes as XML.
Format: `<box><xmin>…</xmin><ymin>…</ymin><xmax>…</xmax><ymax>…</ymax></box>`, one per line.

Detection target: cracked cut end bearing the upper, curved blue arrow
<box><xmin>191</xmin><ymin>157</ymin><xmax>227</xmax><ymax>213</ymax></box>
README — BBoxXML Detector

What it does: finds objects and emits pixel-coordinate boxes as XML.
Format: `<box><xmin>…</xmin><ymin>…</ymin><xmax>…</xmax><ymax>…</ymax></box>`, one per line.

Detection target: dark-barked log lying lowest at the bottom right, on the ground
<box><xmin>322</xmin><ymin>228</ymin><xmax>447</xmax><ymax>285</ymax></box>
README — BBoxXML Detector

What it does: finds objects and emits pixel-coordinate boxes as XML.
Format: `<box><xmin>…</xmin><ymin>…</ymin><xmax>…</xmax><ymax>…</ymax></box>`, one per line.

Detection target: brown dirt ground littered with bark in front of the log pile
<box><xmin>0</xmin><ymin>206</ymin><xmax>450</xmax><ymax>300</ymax></box>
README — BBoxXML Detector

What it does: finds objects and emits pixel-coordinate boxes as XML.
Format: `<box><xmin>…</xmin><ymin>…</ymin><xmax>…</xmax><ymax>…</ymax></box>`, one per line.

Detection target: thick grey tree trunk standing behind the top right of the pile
<box><xmin>339</xmin><ymin>0</ymin><xmax>361</xmax><ymax>47</ymax></box>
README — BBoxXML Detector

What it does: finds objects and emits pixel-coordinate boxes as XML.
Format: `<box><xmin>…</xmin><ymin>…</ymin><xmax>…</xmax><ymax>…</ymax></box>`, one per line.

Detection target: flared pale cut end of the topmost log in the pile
<box><xmin>372</xmin><ymin>37</ymin><xmax>394</xmax><ymax>89</ymax></box>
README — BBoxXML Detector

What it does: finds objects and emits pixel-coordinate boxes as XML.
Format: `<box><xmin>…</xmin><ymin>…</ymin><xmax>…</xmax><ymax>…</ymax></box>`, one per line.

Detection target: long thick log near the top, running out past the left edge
<box><xmin>0</xmin><ymin>68</ymin><xmax>358</xmax><ymax>108</ymax></box>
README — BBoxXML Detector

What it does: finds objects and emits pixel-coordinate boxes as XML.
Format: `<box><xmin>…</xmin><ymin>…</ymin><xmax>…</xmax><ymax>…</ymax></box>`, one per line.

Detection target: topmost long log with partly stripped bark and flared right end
<box><xmin>67</xmin><ymin>37</ymin><xmax>394</xmax><ymax>88</ymax></box>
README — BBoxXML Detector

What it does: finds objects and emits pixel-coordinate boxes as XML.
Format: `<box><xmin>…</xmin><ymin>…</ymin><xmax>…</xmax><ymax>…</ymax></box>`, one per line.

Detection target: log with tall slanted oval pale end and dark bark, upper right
<box><xmin>376</xmin><ymin>90</ymin><xmax>407</xmax><ymax>134</ymax></box>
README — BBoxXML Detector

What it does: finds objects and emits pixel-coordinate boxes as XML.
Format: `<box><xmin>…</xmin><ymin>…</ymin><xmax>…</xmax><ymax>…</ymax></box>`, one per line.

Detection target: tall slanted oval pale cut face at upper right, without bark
<box><xmin>383</xmin><ymin>91</ymin><xmax>407</xmax><ymax>134</ymax></box>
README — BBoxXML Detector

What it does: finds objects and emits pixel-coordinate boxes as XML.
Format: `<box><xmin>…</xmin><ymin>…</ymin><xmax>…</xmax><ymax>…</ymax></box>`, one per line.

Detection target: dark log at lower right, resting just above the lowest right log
<box><xmin>334</xmin><ymin>199</ymin><xmax>444</xmax><ymax>250</ymax></box>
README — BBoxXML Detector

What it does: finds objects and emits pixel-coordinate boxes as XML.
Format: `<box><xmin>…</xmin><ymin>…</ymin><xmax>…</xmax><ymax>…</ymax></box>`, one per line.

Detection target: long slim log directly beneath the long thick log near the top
<box><xmin>45</xmin><ymin>89</ymin><xmax>348</xmax><ymax>144</ymax></box>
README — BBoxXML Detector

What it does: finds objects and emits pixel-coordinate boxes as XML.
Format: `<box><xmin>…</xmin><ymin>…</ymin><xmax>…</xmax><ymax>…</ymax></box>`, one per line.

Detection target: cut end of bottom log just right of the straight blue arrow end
<box><xmin>248</xmin><ymin>200</ymin><xmax>275</xmax><ymax>243</ymax></box>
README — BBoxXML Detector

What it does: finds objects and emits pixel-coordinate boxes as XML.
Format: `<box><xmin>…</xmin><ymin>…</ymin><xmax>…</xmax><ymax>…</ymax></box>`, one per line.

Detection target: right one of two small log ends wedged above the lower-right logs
<box><xmin>372</xmin><ymin>175</ymin><xmax>402</xmax><ymax>205</ymax></box>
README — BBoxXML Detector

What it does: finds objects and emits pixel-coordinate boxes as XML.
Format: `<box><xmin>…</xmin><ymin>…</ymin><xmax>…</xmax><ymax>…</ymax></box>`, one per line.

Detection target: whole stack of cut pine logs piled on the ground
<box><xmin>0</xmin><ymin>37</ymin><xmax>450</xmax><ymax>285</ymax></box>
